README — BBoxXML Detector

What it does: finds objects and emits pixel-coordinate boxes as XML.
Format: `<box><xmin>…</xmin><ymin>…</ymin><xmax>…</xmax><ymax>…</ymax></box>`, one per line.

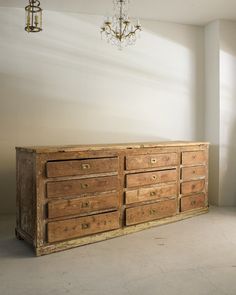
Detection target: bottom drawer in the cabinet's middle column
<box><xmin>126</xmin><ymin>199</ymin><xmax>177</xmax><ymax>225</ymax></box>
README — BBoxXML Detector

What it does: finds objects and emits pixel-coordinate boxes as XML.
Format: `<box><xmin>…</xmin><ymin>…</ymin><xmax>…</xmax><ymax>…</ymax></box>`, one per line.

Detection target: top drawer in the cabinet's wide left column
<box><xmin>46</xmin><ymin>158</ymin><xmax>118</xmax><ymax>177</ymax></box>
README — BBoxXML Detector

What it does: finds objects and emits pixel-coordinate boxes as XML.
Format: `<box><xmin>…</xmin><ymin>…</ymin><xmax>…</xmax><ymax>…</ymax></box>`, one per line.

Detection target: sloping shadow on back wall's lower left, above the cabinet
<box><xmin>0</xmin><ymin>72</ymin><xmax>169</xmax><ymax>213</ymax></box>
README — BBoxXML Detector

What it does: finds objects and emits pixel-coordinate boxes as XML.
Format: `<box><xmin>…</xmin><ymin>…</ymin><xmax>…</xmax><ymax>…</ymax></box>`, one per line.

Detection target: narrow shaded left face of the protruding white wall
<box><xmin>205</xmin><ymin>21</ymin><xmax>220</xmax><ymax>205</ymax></box>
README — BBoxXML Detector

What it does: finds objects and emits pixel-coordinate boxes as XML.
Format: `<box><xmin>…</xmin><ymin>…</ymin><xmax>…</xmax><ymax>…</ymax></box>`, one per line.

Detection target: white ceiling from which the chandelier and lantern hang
<box><xmin>0</xmin><ymin>0</ymin><xmax>236</xmax><ymax>25</ymax></box>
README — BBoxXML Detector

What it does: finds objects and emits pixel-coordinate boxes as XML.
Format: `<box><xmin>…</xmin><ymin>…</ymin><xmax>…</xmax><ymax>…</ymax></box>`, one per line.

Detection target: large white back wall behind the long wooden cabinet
<box><xmin>0</xmin><ymin>8</ymin><xmax>204</xmax><ymax>213</ymax></box>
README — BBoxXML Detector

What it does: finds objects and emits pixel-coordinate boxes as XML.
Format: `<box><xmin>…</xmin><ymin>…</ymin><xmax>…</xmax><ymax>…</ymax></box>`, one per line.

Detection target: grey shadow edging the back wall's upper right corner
<box><xmin>144</xmin><ymin>21</ymin><xmax>205</xmax><ymax>140</ymax></box>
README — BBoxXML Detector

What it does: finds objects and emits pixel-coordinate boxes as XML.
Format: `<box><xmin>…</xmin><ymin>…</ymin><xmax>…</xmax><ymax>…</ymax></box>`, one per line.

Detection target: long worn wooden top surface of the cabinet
<box><xmin>16</xmin><ymin>141</ymin><xmax>209</xmax><ymax>154</ymax></box>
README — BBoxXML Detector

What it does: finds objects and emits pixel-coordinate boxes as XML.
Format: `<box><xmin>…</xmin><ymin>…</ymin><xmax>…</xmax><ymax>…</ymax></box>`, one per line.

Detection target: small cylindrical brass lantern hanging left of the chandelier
<box><xmin>25</xmin><ymin>0</ymin><xmax>42</xmax><ymax>33</ymax></box>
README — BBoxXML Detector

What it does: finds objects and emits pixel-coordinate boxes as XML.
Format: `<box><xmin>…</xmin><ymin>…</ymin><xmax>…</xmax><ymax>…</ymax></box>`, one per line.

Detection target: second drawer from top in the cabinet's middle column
<box><xmin>126</xmin><ymin>169</ymin><xmax>177</xmax><ymax>188</ymax></box>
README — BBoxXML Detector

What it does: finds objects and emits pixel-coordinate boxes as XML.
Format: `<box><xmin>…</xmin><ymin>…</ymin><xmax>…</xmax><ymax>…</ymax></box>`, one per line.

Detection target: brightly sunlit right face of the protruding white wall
<box><xmin>219</xmin><ymin>21</ymin><xmax>236</xmax><ymax>206</ymax></box>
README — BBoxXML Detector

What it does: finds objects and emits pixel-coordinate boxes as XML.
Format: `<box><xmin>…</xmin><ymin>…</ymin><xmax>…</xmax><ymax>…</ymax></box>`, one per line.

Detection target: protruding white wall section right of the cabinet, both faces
<box><xmin>205</xmin><ymin>20</ymin><xmax>236</xmax><ymax>206</ymax></box>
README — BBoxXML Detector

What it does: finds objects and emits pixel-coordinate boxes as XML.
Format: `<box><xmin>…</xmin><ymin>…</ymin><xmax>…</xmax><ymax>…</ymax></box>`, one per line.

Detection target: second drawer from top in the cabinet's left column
<box><xmin>47</xmin><ymin>176</ymin><xmax>118</xmax><ymax>198</ymax></box>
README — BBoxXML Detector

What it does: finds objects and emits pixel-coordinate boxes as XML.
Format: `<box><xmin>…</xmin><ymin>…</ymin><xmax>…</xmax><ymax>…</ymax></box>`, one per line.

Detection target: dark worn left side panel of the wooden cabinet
<box><xmin>16</xmin><ymin>151</ymin><xmax>36</xmax><ymax>241</ymax></box>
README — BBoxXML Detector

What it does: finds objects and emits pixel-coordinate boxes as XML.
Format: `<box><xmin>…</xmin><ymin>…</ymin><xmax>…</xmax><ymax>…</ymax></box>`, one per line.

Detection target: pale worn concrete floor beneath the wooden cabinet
<box><xmin>0</xmin><ymin>208</ymin><xmax>236</xmax><ymax>295</ymax></box>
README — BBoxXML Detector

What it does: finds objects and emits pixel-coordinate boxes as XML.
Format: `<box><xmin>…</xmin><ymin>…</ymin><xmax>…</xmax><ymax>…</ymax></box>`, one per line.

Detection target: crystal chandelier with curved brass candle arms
<box><xmin>101</xmin><ymin>0</ymin><xmax>142</xmax><ymax>49</ymax></box>
